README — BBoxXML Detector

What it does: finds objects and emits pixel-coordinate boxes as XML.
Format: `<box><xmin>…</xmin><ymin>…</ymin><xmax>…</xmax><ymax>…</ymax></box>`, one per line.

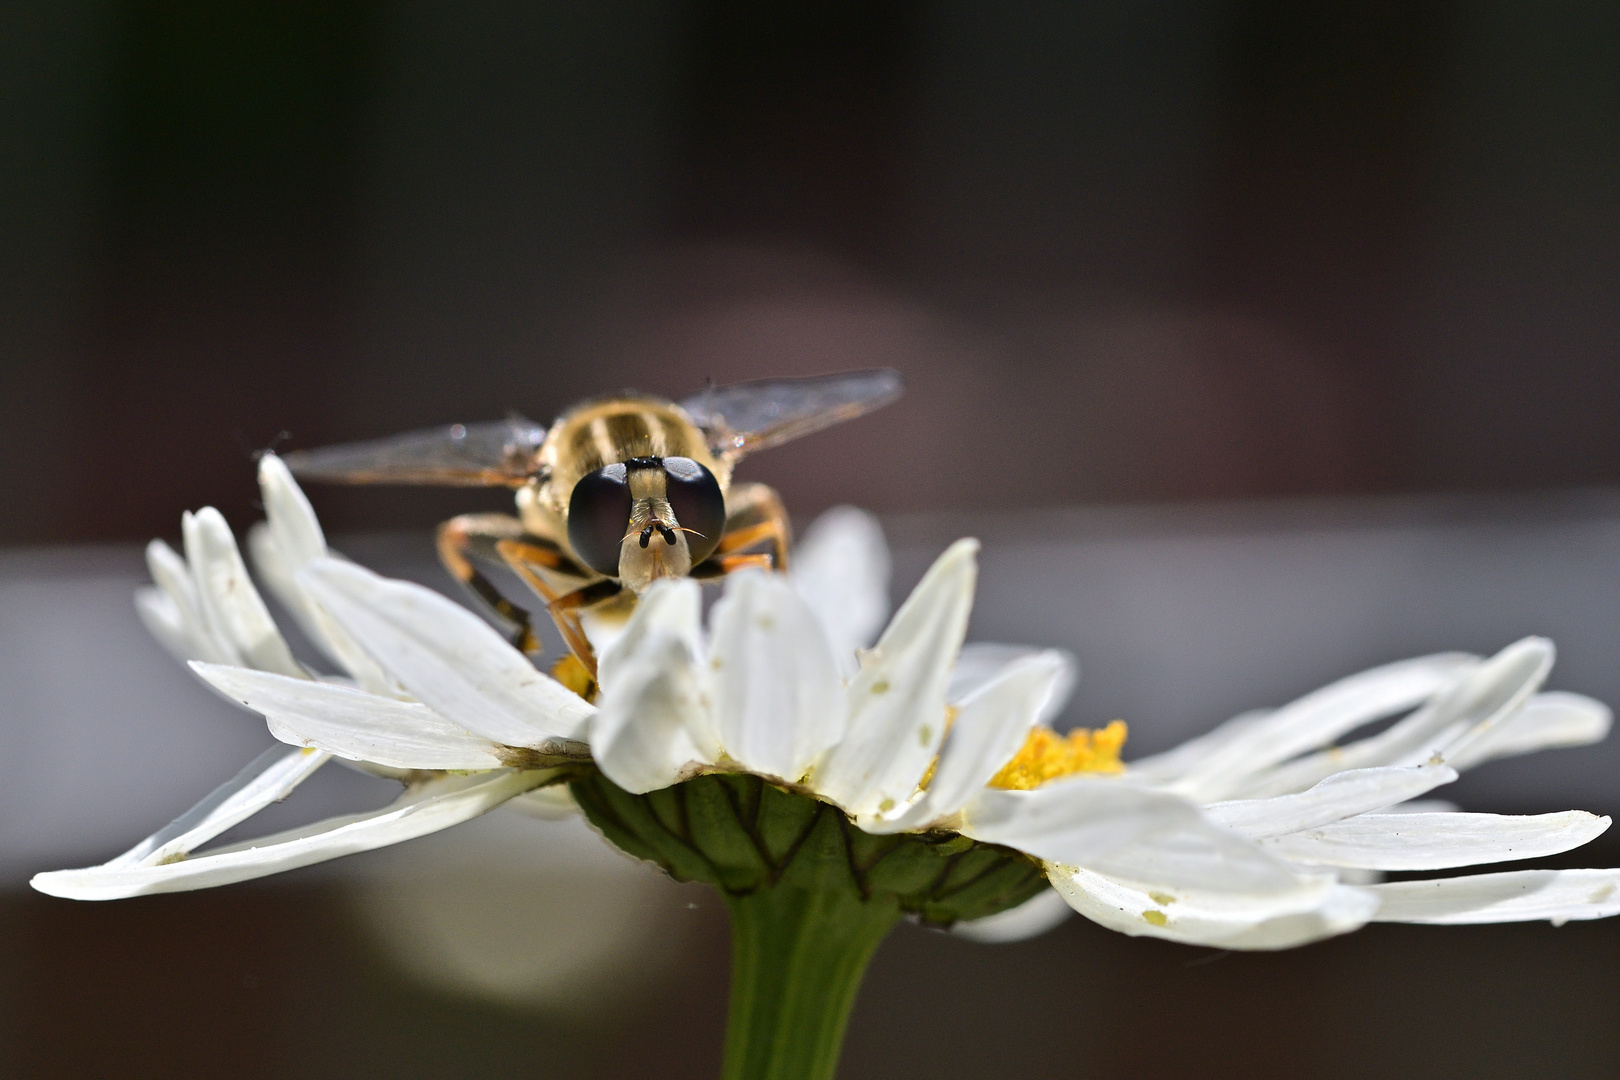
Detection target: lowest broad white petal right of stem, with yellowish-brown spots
<box><xmin>1047</xmin><ymin>865</ymin><xmax>1379</xmax><ymax>949</ymax></box>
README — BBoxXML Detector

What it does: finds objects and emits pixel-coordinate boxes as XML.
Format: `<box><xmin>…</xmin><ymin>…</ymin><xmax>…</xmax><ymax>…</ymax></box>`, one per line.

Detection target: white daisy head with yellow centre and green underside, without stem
<box><xmin>34</xmin><ymin>457</ymin><xmax>1620</xmax><ymax>952</ymax></box>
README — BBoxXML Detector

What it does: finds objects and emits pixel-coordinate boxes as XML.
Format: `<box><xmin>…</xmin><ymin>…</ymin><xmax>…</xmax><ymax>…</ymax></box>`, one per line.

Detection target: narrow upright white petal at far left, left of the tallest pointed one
<box><xmin>180</xmin><ymin>507</ymin><xmax>308</xmax><ymax>678</ymax></box>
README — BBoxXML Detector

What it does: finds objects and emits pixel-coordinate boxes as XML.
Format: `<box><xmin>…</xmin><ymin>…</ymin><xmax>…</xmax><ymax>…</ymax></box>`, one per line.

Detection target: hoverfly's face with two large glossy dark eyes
<box><xmin>569</xmin><ymin>457</ymin><xmax>726</xmax><ymax>593</ymax></box>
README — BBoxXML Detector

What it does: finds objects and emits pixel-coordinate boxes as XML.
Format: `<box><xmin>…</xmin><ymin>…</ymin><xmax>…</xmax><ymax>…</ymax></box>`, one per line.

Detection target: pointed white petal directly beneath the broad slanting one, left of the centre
<box><xmin>191</xmin><ymin>662</ymin><xmax>511</xmax><ymax>769</ymax></box>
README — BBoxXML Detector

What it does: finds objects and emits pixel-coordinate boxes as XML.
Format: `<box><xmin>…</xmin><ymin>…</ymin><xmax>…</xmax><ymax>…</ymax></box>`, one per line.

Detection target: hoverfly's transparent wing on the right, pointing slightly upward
<box><xmin>680</xmin><ymin>368</ymin><xmax>906</xmax><ymax>460</ymax></box>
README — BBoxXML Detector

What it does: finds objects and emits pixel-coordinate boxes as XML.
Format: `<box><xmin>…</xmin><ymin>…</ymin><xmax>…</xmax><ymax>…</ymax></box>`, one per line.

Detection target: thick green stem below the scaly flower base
<box><xmin>721</xmin><ymin>887</ymin><xmax>901</xmax><ymax>1080</ymax></box>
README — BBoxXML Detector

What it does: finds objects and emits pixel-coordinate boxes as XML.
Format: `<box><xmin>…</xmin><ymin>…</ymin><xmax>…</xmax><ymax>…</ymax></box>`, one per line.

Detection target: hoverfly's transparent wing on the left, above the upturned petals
<box><xmin>284</xmin><ymin>416</ymin><xmax>546</xmax><ymax>487</ymax></box>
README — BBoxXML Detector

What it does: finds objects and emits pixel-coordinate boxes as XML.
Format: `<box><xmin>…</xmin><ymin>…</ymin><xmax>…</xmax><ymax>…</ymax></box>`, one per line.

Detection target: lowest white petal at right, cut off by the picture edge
<box><xmin>1371</xmin><ymin>870</ymin><xmax>1620</xmax><ymax>926</ymax></box>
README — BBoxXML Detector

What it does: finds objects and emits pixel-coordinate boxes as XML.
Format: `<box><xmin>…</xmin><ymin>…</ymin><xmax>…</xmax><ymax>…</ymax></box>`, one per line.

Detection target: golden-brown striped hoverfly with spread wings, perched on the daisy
<box><xmin>285</xmin><ymin>369</ymin><xmax>902</xmax><ymax>677</ymax></box>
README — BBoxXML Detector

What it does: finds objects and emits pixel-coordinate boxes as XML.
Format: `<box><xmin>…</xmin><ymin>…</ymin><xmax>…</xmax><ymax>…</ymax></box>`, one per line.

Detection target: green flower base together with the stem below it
<box><xmin>570</xmin><ymin>772</ymin><xmax>1047</xmax><ymax>1080</ymax></box>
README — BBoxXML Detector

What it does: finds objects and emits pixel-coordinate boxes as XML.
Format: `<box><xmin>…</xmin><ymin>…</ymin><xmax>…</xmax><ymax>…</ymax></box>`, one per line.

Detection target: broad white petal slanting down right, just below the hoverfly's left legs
<box><xmin>298</xmin><ymin>559</ymin><xmax>595</xmax><ymax>748</ymax></box>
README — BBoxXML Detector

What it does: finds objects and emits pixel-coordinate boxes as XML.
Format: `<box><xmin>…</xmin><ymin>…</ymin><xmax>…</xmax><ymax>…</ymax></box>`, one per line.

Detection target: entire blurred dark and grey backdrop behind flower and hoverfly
<box><xmin>0</xmin><ymin>0</ymin><xmax>1620</xmax><ymax>1077</ymax></box>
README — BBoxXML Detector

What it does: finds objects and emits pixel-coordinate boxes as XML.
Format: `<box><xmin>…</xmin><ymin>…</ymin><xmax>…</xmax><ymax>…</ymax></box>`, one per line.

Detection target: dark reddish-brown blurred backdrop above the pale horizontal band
<box><xmin>9</xmin><ymin>0</ymin><xmax>1620</xmax><ymax>542</ymax></box>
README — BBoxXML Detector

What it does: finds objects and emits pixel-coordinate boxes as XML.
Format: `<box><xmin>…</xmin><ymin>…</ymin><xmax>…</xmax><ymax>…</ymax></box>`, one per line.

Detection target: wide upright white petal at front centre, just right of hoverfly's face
<box><xmin>708</xmin><ymin>570</ymin><xmax>847</xmax><ymax>780</ymax></box>
